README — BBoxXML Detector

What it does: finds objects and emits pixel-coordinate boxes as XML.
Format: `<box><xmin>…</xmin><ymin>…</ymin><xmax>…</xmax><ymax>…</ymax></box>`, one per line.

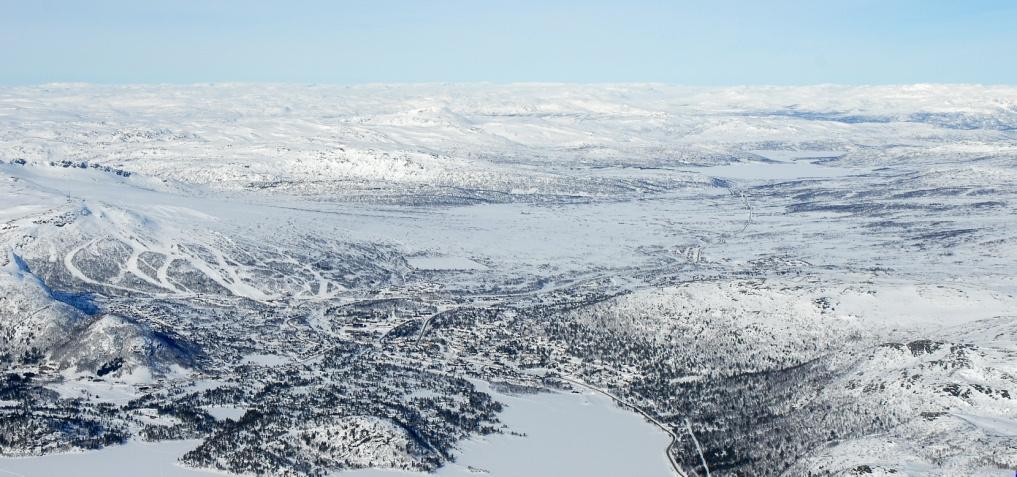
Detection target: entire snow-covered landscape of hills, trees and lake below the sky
<box><xmin>0</xmin><ymin>84</ymin><xmax>1017</xmax><ymax>477</ymax></box>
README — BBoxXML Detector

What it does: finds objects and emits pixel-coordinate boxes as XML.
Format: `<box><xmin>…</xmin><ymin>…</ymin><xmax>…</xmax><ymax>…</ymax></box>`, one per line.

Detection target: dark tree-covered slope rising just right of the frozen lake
<box><xmin>536</xmin><ymin>292</ymin><xmax>899</xmax><ymax>476</ymax></box>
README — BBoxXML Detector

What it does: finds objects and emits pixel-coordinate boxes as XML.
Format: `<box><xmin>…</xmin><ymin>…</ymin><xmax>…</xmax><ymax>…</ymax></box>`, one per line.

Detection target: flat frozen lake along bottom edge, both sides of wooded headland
<box><xmin>0</xmin><ymin>382</ymin><xmax>673</xmax><ymax>477</ymax></box>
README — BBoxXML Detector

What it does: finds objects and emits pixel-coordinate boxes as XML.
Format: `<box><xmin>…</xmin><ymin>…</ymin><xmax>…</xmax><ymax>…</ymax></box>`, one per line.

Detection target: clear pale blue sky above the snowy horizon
<box><xmin>0</xmin><ymin>0</ymin><xmax>1017</xmax><ymax>85</ymax></box>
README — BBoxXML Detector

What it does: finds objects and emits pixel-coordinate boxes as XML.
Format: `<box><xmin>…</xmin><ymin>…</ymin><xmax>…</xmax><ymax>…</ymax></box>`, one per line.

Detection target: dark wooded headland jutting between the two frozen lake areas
<box><xmin>120</xmin><ymin>340</ymin><xmax>501</xmax><ymax>476</ymax></box>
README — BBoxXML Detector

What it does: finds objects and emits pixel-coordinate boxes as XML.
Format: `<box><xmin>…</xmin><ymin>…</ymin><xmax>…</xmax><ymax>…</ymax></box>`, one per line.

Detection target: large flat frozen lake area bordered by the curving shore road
<box><xmin>336</xmin><ymin>382</ymin><xmax>673</xmax><ymax>477</ymax></box>
